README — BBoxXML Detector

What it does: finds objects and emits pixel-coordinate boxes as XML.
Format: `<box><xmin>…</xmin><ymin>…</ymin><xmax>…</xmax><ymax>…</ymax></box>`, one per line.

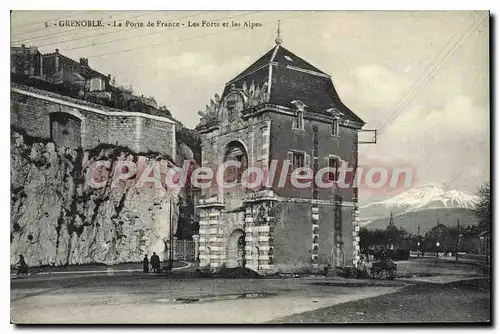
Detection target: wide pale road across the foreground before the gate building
<box><xmin>11</xmin><ymin>260</ymin><xmax>489</xmax><ymax>324</ymax></box>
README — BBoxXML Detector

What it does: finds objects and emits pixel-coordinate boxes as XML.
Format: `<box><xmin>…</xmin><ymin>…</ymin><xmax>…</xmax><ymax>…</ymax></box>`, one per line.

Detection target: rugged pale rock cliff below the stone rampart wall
<box><xmin>10</xmin><ymin>131</ymin><xmax>182</xmax><ymax>266</ymax></box>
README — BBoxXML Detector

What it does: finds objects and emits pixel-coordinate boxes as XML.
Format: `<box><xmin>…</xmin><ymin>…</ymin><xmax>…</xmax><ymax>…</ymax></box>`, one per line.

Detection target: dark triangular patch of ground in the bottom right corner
<box><xmin>274</xmin><ymin>278</ymin><xmax>491</xmax><ymax>323</ymax></box>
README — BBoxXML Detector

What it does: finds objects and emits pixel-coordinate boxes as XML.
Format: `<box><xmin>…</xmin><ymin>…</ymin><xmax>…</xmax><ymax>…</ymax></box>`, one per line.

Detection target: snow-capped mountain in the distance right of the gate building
<box><xmin>360</xmin><ymin>183</ymin><xmax>478</xmax><ymax>222</ymax></box>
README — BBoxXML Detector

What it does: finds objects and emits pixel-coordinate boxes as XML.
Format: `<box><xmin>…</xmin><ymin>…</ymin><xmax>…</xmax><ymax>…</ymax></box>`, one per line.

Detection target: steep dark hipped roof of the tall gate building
<box><xmin>222</xmin><ymin>44</ymin><xmax>365</xmax><ymax>124</ymax></box>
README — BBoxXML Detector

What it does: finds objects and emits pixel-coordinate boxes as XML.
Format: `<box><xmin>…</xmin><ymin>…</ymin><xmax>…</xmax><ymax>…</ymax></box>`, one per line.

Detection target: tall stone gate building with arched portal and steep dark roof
<box><xmin>197</xmin><ymin>39</ymin><xmax>364</xmax><ymax>274</ymax></box>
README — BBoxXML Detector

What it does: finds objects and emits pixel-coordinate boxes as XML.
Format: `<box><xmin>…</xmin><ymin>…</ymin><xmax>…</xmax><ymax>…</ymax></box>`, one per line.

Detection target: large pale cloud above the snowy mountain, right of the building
<box><xmin>360</xmin><ymin>95</ymin><xmax>490</xmax><ymax>197</ymax></box>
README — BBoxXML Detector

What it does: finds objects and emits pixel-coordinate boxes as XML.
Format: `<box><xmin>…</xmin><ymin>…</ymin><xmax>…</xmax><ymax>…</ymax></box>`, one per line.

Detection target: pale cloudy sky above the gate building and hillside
<box><xmin>11</xmin><ymin>11</ymin><xmax>490</xmax><ymax>196</ymax></box>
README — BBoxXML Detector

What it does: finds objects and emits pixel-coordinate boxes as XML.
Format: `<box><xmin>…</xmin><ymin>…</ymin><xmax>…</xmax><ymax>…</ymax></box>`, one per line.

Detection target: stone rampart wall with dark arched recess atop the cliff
<box><xmin>11</xmin><ymin>85</ymin><xmax>176</xmax><ymax>159</ymax></box>
